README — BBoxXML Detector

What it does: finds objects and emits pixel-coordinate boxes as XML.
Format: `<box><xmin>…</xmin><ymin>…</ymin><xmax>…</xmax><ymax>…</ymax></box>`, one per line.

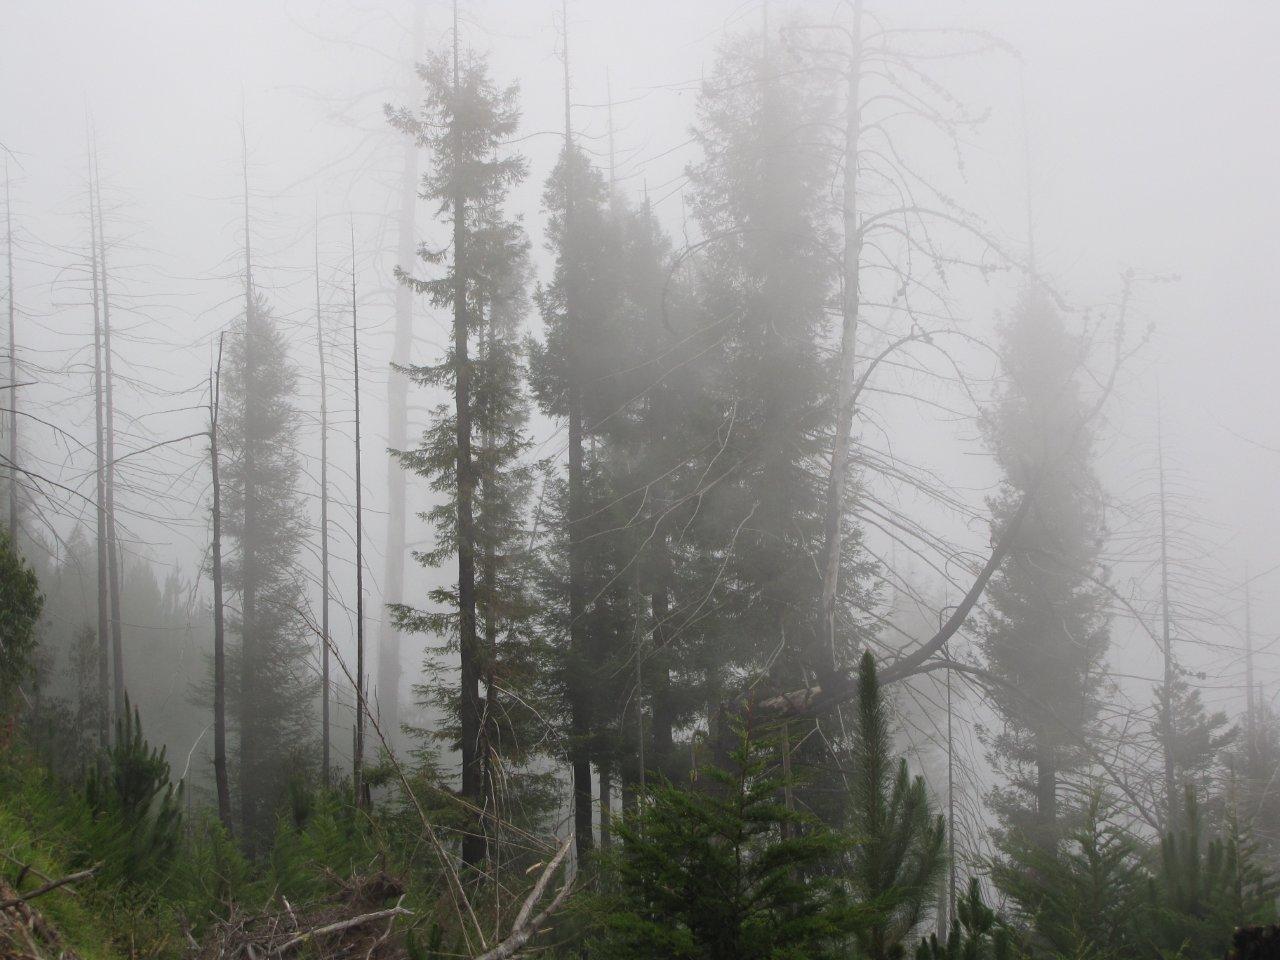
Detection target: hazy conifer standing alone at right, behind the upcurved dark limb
<box><xmin>980</xmin><ymin>285</ymin><xmax>1107</xmax><ymax>841</ymax></box>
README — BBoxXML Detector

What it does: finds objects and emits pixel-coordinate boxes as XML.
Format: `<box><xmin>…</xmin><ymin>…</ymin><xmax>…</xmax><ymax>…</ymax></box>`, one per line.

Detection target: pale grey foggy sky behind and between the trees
<box><xmin>0</xmin><ymin>0</ymin><xmax>1280</xmax><ymax>870</ymax></box>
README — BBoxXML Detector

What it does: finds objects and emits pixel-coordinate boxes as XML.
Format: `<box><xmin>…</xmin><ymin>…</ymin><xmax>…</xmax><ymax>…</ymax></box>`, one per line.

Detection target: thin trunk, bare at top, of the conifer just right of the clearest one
<box><xmin>561</xmin><ymin>0</ymin><xmax>594</xmax><ymax>860</ymax></box>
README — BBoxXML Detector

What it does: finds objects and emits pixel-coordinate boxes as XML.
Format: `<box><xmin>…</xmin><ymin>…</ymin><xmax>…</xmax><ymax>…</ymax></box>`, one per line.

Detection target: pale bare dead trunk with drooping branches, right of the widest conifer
<box><xmin>813</xmin><ymin>0</ymin><xmax>863</xmax><ymax>685</ymax></box>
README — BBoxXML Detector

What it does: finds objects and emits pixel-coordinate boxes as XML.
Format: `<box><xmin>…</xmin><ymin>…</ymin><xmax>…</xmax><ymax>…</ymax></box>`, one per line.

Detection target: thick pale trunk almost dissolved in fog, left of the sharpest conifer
<box><xmin>378</xmin><ymin>3</ymin><xmax>424</xmax><ymax>744</ymax></box>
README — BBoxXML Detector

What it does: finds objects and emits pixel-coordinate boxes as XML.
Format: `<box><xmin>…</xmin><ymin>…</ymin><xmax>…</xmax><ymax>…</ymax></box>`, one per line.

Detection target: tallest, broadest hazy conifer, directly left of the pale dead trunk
<box><xmin>690</xmin><ymin>20</ymin><xmax>858</xmax><ymax>685</ymax></box>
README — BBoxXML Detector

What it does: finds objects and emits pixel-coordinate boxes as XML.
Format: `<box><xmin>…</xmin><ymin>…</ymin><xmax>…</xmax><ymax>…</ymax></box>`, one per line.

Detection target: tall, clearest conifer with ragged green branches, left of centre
<box><xmin>390</xmin><ymin>28</ymin><xmax>530</xmax><ymax>864</ymax></box>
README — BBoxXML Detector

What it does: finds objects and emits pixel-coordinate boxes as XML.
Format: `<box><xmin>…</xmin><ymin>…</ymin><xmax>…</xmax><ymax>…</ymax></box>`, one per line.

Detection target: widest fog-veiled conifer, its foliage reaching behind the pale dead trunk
<box><xmin>687</xmin><ymin>15</ymin><xmax>872</xmax><ymax>823</ymax></box>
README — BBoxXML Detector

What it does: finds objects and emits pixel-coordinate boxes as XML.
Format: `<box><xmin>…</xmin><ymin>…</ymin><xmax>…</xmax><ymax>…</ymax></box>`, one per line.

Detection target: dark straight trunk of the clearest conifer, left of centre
<box><xmin>451</xmin><ymin>4</ymin><xmax>485</xmax><ymax>865</ymax></box>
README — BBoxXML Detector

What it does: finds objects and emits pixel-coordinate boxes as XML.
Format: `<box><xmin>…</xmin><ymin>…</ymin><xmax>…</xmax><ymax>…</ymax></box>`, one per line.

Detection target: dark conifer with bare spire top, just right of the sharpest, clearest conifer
<box><xmin>530</xmin><ymin>138</ymin><xmax>640</xmax><ymax>852</ymax></box>
